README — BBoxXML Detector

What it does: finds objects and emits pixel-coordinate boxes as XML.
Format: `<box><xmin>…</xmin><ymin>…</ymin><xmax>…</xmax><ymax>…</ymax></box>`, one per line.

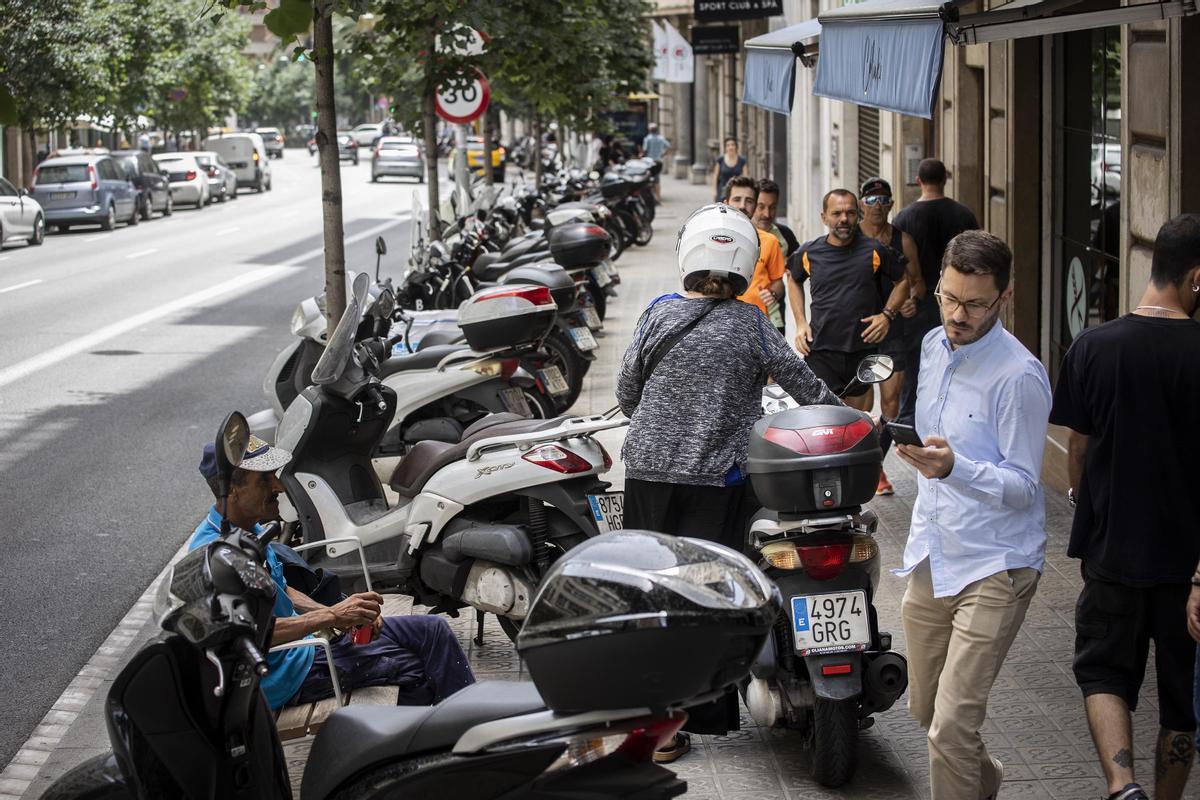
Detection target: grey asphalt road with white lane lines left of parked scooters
<box><xmin>0</xmin><ymin>150</ymin><xmax>441</xmax><ymax>764</ymax></box>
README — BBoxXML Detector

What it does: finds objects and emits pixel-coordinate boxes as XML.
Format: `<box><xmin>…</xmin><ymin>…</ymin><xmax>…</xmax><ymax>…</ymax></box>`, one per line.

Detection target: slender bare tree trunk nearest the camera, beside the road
<box><xmin>313</xmin><ymin>5</ymin><xmax>346</xmax><ymax>337</ymax></box>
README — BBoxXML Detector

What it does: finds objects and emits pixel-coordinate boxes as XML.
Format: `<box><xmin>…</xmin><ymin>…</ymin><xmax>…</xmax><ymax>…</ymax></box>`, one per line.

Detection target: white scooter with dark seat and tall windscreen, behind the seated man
<box><xmin>277</xmin><ymin>275</ymin><xmax>628</xmax><ymax>634</ymax></box>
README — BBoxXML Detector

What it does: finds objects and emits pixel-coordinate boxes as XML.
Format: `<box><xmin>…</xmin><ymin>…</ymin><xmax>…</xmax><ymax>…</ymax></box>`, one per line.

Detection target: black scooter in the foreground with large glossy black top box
<box><xmin>43</xmin><ymin>510</ymin><xmax>780</xmax><ymax>800</ymax></box>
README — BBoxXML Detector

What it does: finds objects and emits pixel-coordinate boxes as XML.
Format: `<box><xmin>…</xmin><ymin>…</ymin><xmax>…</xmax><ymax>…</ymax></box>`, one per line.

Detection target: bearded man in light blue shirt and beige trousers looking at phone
<box><xmin>895</xmin><ymin>231</ymin><xmax>1050</xmax><ymax>800</ymax></box>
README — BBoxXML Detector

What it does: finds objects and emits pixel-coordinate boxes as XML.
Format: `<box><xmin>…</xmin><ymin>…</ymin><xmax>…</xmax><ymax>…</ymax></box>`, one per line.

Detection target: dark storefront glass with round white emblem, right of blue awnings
<box><xmin>1050</xmin><ymin>28</ymin><xmax>1121</xmax><ymax>377</ymax></box>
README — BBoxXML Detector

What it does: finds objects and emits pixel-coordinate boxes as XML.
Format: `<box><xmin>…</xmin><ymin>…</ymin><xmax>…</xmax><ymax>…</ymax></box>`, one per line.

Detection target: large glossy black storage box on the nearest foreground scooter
<box><xmin>517</xmin><ymin>530</ymin><xmax>780</xmax><ymax>712</ymax></box>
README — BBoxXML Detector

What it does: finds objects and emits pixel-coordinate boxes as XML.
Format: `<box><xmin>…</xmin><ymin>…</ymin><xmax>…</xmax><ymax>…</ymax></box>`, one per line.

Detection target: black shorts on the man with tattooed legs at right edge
<box><xmin>1073</xmin><ymin>573</ymin><xmax>1196</xmax><ymax>730</ymax></box>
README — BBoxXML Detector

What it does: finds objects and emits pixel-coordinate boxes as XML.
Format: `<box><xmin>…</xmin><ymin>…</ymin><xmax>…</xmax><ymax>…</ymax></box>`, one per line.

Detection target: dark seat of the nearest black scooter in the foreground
<box><xmin>300</xmin><ymin>680</ymin><xmax>546</xmax><ymax>798</ymax></box>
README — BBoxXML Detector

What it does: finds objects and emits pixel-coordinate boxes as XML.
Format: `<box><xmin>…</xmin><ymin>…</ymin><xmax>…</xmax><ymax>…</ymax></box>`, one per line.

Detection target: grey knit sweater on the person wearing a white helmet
<box><xmin>617</xmin><ymin>295</ymin><xmax>841</xmax><ymax>486</ymax></box>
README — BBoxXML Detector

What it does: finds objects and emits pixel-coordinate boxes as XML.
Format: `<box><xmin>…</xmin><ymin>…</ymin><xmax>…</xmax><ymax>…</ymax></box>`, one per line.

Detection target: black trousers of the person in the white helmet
<box><xmin>624</xmin><ymin>479</ymin><xmax>758</xmax><ymax>736</ymax></box>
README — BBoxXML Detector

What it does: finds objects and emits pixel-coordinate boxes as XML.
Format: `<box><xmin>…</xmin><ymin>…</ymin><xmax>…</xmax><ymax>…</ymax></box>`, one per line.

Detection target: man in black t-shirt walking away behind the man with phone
<box><xmin>892</xmin><ymin>158</ymin><xmax>979</xmax><ymax>425</ymax></box>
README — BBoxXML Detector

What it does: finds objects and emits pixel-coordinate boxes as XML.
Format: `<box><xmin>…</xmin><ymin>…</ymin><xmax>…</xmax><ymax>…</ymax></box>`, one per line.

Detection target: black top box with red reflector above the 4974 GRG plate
<box><xmin>746</xmin><ymin>405</ymin><xmax>883</xmax><ymax>515</ymax></box>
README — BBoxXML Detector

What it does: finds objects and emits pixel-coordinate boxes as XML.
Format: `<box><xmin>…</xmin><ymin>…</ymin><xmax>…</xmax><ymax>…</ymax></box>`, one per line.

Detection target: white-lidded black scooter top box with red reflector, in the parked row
<box><xmin>458</xmin><ymin>284</ymin><xmax>558</xmax><ymax>350</ymax></box>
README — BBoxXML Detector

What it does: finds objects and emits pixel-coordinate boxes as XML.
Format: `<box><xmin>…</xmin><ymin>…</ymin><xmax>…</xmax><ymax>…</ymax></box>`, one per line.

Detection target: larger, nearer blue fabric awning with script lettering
<box><xmin>812</xmin><ymin>0</ymin><xmax>950</xmax><ymax>119</ymax></box>
